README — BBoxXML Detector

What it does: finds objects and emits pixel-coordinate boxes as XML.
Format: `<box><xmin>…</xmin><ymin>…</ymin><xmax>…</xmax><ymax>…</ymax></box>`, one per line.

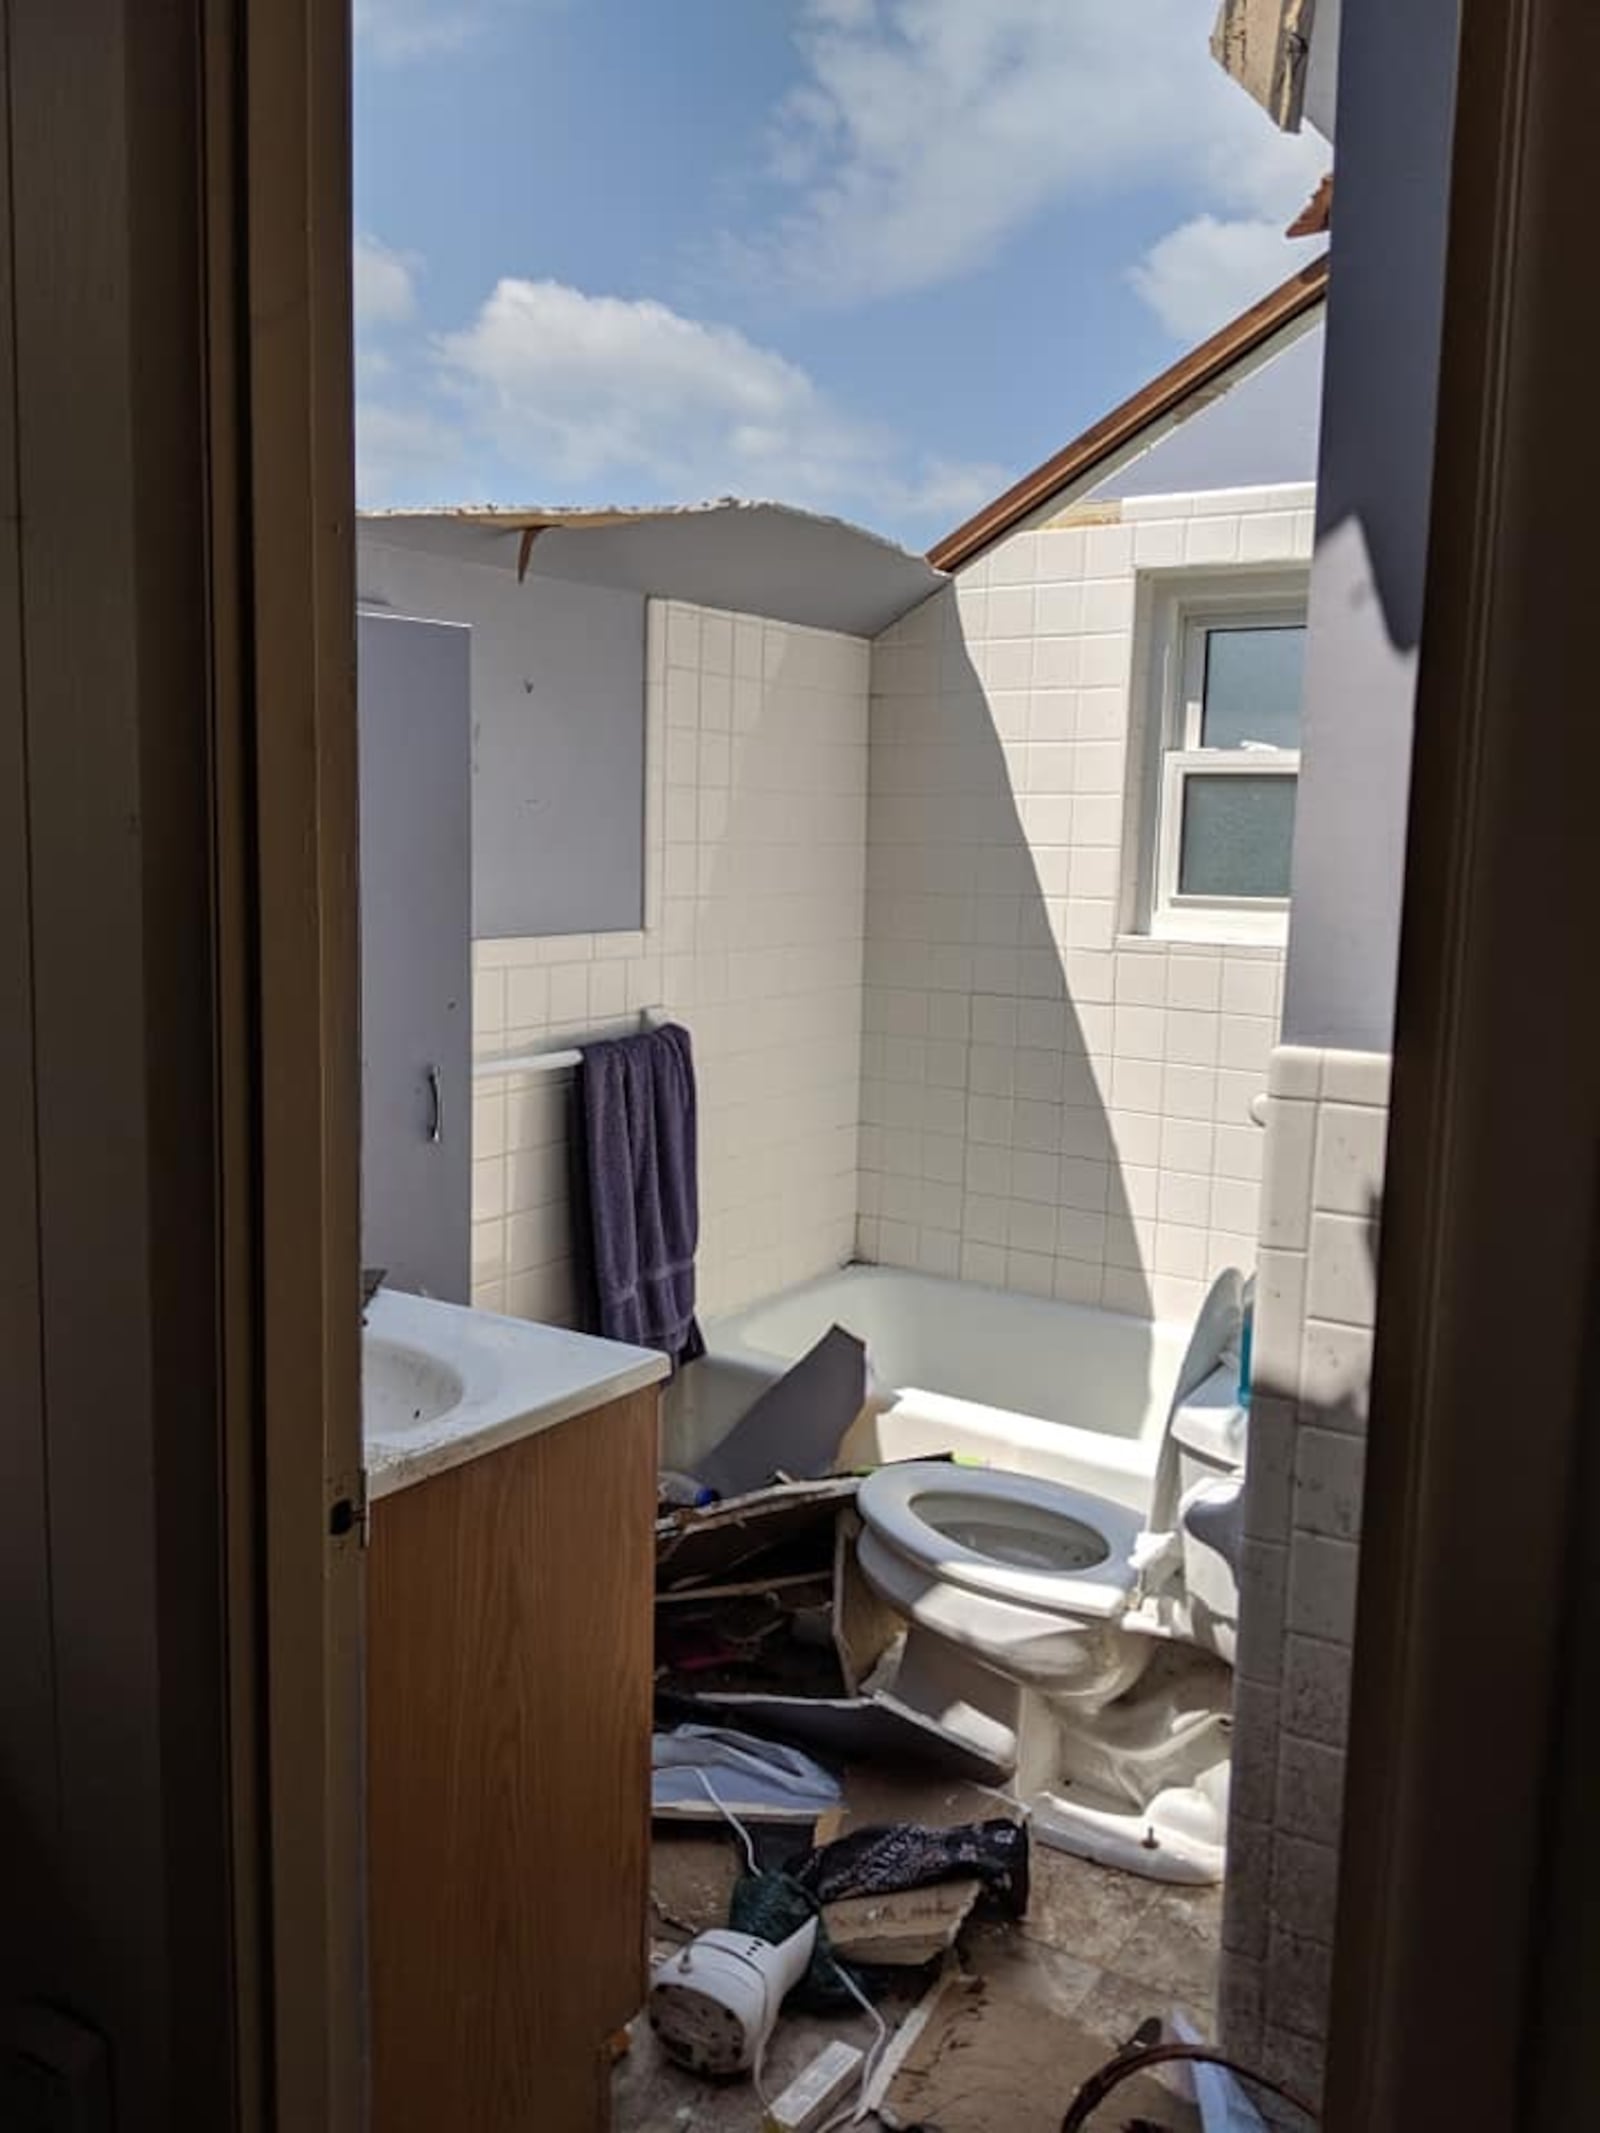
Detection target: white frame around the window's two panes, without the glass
<box><xmin>1143</xmin><ymin>570</ymin><xmax>1308</xmax><ymax>945</ymax></box>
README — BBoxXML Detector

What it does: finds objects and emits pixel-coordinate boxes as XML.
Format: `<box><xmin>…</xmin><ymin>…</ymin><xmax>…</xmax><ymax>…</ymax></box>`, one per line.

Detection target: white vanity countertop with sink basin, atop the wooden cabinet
<box><xmin>363</xmin><ymin>1288</ymin><xmax>668</xmax><ymax>1499</ymax></box>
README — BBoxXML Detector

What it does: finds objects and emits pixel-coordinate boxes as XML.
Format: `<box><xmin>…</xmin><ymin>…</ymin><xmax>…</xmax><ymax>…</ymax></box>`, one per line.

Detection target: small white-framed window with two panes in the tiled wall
<box><xmin>1148</xmin><ymin>587</ymin><xmax>1306</xmax><ymax>941</ymax></box>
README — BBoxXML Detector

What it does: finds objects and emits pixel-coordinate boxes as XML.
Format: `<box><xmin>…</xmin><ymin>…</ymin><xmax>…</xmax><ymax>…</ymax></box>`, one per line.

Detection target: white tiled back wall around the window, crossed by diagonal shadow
<box><xmin>860</xmin><ymin>486</ymin><xmax>1312</xmax><ymax>1316</ymax></box>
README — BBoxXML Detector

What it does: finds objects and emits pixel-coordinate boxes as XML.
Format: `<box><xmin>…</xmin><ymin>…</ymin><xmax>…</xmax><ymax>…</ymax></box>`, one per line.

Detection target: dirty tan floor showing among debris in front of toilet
<box><xmin>614</xmin><ymin>1770</ymin><xmax>1222</xmax><ymax>2133</ymax></box>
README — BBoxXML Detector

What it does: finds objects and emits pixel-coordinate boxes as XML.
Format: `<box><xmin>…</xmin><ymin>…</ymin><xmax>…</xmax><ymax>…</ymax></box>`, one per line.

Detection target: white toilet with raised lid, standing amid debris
<box><xmin>855</xmin><ymin>1271</ymin><xmax>1246</xmax><ymax>1883</ymax></box>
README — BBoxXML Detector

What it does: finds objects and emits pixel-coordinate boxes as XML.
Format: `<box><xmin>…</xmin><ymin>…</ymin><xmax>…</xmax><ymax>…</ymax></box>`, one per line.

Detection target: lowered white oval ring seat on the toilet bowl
<box><xmin>858</xmin><ymin>1461</ymin><xmax>1143</xmax><ymax>1621</ymax></box>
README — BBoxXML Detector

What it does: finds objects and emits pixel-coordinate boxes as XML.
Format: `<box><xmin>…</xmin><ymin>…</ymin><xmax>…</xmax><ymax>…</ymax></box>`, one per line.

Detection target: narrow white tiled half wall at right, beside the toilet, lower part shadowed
<box><xmin>1222</xmin><ymin>1045</ymin><xmax>1389</xmax><ymax>2095</ymax></box>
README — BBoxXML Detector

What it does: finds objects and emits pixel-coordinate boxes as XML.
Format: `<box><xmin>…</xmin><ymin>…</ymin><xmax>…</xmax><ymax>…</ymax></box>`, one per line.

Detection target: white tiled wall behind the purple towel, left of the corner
<box><xmin>474</xmin><ymin>602</ymin><xmax>870</xmax><ymax>1322</ymax></box>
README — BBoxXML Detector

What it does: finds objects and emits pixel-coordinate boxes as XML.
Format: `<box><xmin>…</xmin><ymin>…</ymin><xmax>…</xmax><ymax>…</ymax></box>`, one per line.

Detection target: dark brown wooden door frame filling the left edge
<box><xmin>0</xmin><ymin>0</ymin><xmax>365</xmax><ymax>2133</ymax></box>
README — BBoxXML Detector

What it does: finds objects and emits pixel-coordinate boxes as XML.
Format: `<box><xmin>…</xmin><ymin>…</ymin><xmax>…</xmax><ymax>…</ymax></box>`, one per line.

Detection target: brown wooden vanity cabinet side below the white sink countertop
<box><xmin>367</xmin><ymin>1389</ymin><xmax>657</xmax><ymax>2133</ymax></box>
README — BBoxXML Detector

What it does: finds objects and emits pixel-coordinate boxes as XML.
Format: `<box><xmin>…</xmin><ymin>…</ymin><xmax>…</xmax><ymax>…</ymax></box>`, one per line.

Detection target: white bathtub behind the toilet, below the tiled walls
<box><xmin>666</xmin><ymin>1267</ymin><xmax>1190</xmax><ymax>1510</ymax></box>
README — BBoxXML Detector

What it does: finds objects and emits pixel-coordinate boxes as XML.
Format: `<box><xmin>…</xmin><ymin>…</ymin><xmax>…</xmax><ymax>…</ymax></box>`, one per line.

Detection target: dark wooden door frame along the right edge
<box><xmin>1325</xmin><ymin>0</ymin><xmax>1600</xmax><ymax>2133</ymax></box>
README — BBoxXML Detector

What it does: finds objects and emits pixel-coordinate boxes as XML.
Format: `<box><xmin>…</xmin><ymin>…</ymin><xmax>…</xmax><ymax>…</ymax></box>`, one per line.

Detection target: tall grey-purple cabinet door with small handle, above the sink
<box><xmin>358</xmin><ymin>614</ymin><xmax>471</xmax><ymax>1303</ymax></box>
